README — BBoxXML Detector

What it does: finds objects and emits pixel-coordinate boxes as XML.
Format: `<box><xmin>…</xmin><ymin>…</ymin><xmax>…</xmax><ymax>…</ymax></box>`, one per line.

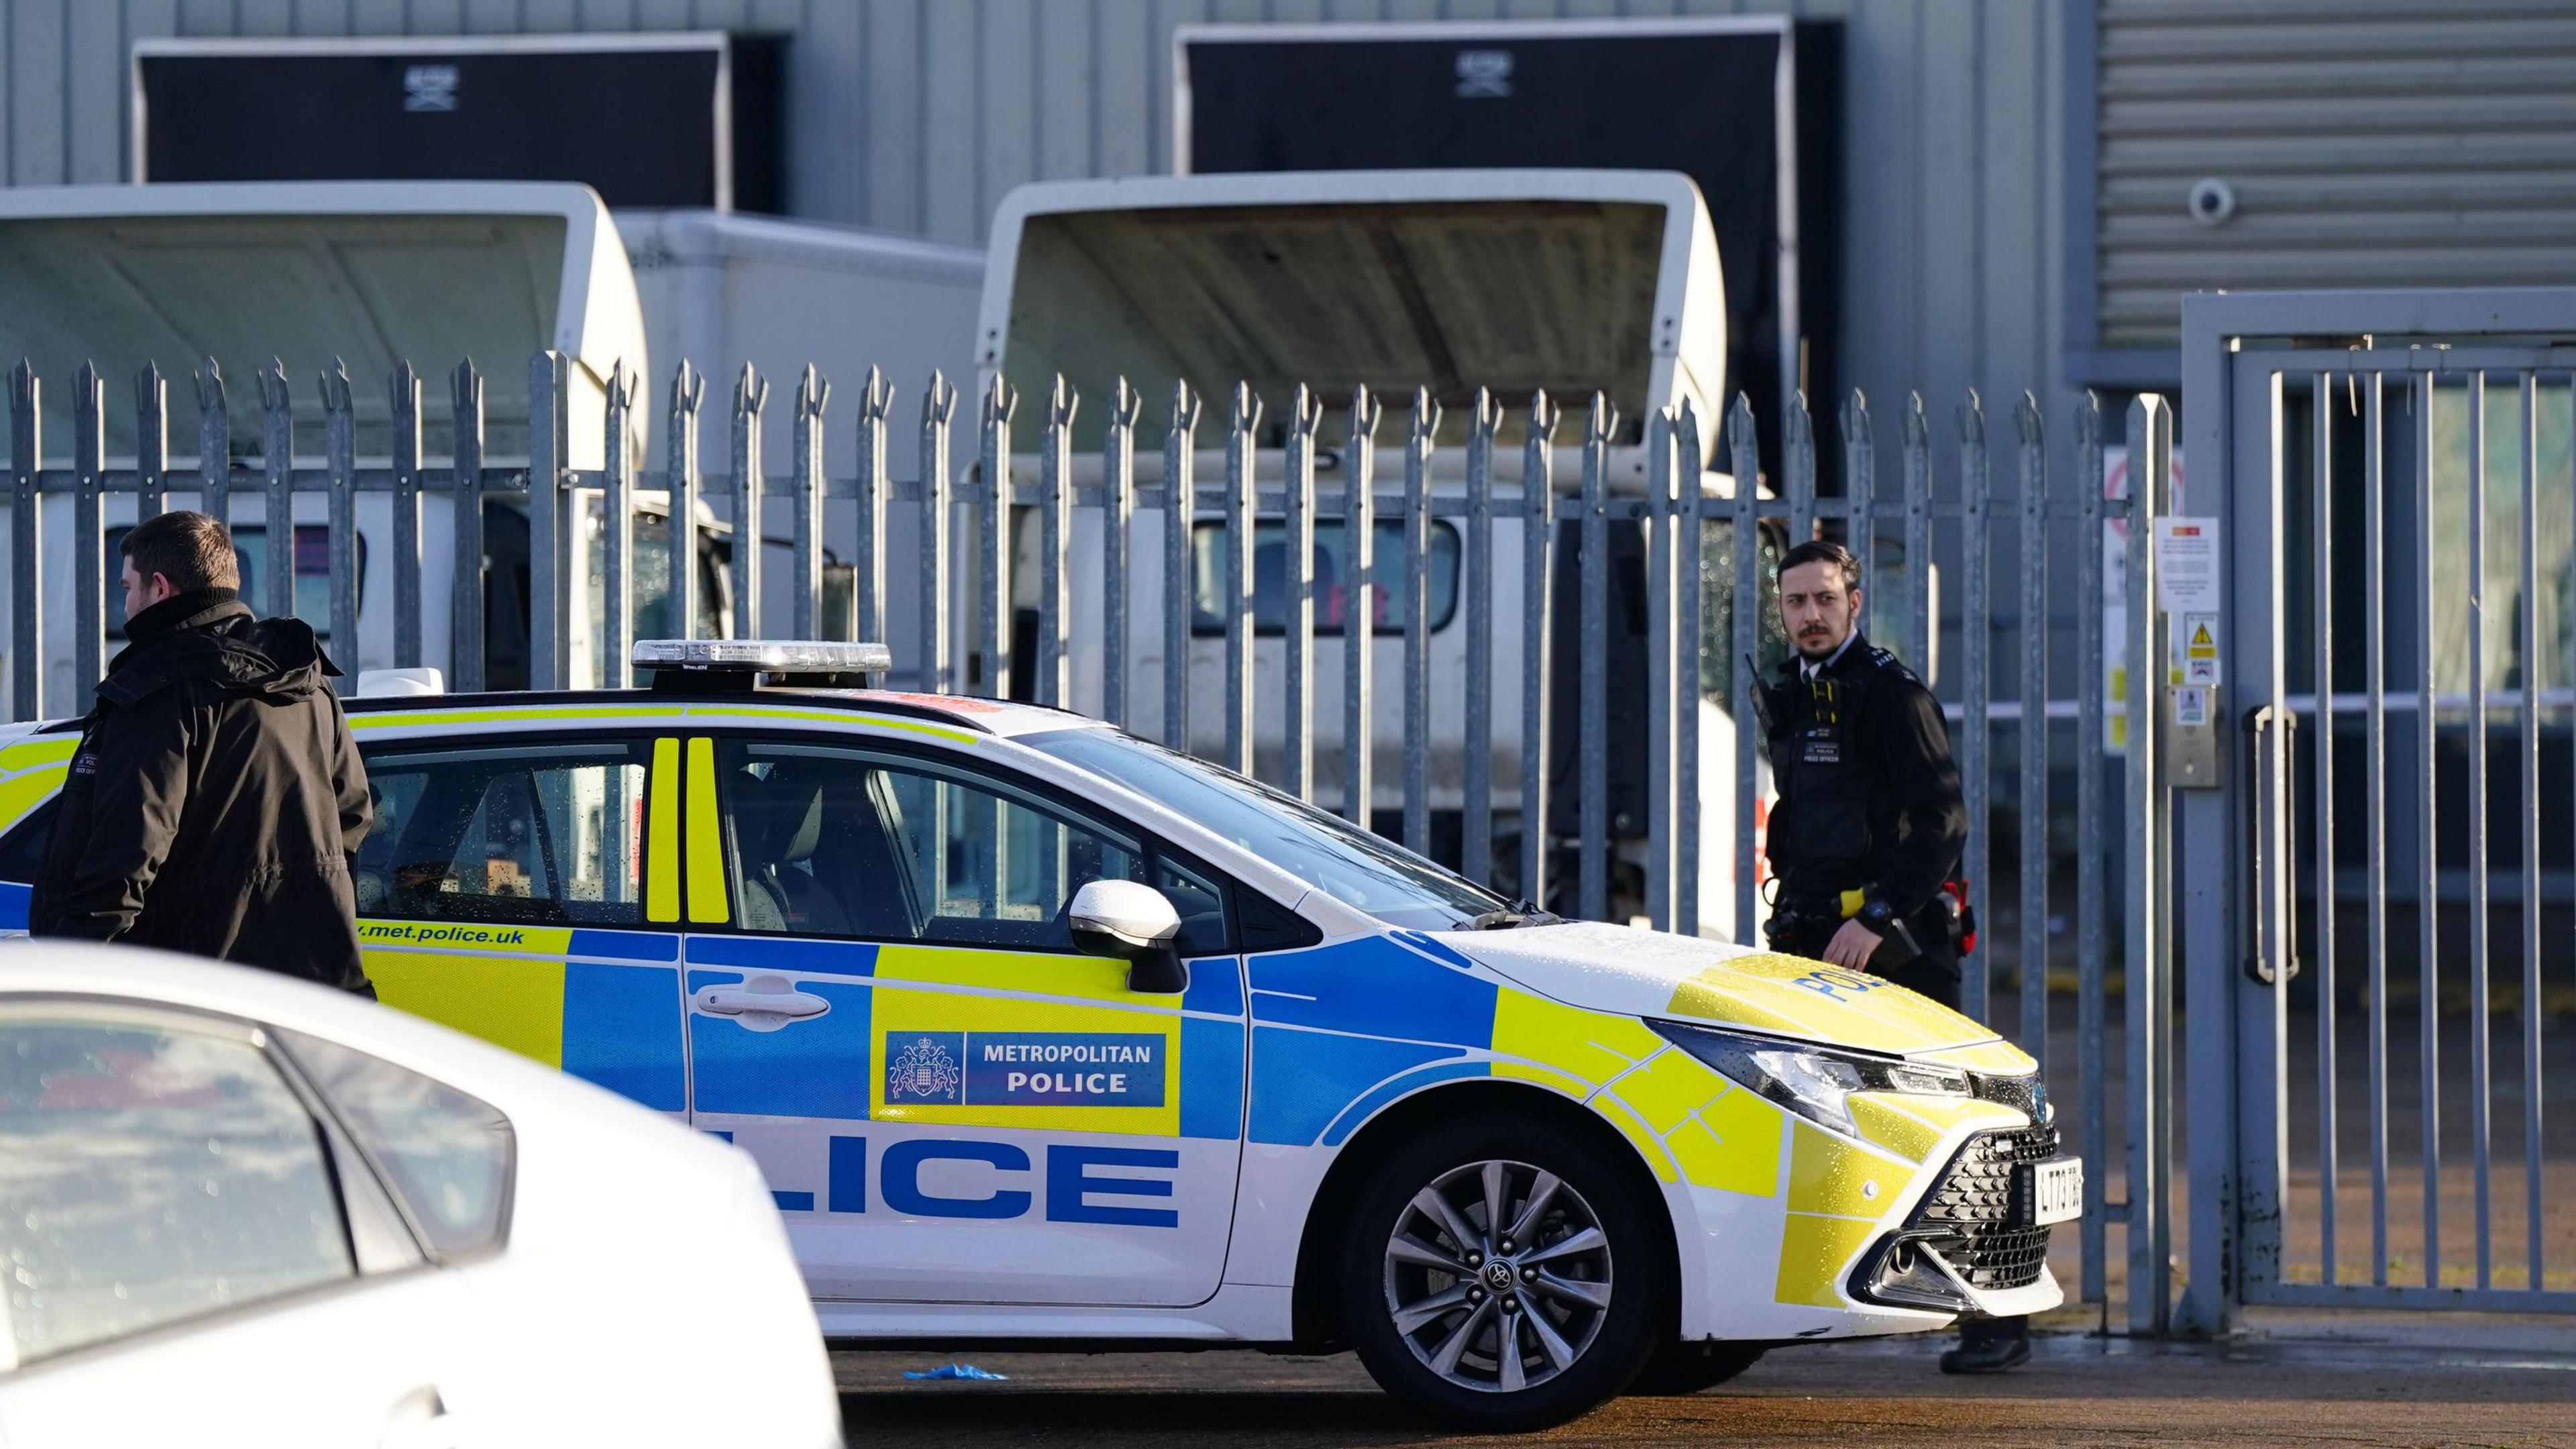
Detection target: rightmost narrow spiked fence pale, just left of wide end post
<box><xmin>2076</xmin><ymin>392</ymin><xmax>2102</xmax><ymax>1312</ymax></box>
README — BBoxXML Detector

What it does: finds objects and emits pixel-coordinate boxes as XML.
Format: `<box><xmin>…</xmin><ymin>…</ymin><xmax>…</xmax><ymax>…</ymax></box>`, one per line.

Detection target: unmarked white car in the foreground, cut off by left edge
<box><xmin>0</xmin><ymin>941</ymin><xmax>840</xmax><ymax>1449</ymax></box>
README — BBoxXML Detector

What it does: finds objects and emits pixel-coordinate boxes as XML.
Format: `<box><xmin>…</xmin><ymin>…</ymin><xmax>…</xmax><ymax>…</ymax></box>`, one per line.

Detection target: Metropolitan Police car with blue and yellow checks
<box><xmin>0</xmin><ymin>642</ymin><xmax>2082</xmax><ymax>1428</ymax></box>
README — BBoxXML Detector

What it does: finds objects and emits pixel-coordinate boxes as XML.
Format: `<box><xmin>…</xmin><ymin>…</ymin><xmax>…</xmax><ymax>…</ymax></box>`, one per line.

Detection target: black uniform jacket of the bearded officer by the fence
<box><xmin>1764</xmin><ymin>632</ymin><xmax>1968</xmax><ymax>918</ymax></box>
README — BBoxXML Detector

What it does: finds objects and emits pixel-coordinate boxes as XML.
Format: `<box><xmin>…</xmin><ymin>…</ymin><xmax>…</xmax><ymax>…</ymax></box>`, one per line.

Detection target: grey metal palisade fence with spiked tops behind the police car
<box><xmin>8</xmin><ymin>354</ymin><xmax>2171</xmax><ymax>1330</ymax></box>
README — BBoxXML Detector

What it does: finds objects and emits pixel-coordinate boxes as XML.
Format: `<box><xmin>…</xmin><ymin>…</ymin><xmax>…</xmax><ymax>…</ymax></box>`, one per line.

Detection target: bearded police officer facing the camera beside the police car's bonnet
<box><xmin>1754</xmin><ymin>539</ymin><xmax>2030</xmax><ymax>1375</ymax></box>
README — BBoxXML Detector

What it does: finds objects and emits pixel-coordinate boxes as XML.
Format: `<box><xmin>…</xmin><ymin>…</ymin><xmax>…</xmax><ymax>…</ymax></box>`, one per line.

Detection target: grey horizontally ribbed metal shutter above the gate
<box><xmin>2094</xmin><ymin>0</ymin><xmax>2576</xmax><ymax>348</ymax></box>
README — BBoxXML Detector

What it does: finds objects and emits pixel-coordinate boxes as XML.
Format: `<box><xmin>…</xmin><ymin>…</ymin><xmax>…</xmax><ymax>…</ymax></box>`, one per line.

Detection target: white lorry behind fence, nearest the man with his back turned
<box><xmin>0</xmin><ymin>180</ymin><xmax>981</xmax><ymax>714</ymax></box>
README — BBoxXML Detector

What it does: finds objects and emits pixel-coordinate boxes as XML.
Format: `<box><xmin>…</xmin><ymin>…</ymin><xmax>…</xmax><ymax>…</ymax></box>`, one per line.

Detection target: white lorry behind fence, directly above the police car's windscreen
<box><xmin>973</xmin><ymin>170</ymin><xmax>1775</xmax><ymax>922</ymax></box>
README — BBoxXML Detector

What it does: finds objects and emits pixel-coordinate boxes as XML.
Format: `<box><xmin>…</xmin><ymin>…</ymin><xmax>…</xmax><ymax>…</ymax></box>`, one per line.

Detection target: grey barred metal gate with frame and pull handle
<box><xmin>2174</xmin><ymin>288</ymin><xmax>2576</xmax><ymax>1330</ymax></box>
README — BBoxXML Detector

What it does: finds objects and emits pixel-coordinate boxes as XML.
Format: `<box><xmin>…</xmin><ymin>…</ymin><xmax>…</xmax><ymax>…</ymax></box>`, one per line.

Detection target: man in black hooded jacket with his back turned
<box><xmin>28</xmin><ymin>513</ymin><xmax>374</xmax><ymax>996</ymax></box>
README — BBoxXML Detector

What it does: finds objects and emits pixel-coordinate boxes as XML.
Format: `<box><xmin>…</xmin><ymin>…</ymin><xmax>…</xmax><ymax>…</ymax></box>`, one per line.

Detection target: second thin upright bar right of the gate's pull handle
<box><xmin>2362</xmin><ymin>369</ymin><xmax>2390</xmax><ymax>1287</ymax></box>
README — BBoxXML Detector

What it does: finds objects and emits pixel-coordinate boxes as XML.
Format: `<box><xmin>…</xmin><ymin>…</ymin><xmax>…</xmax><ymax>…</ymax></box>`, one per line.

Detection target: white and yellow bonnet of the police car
<box><xmin>1438</xmin><ymin>923</ymin><xmax>2030</xmax><ymax>1073</ymax></box>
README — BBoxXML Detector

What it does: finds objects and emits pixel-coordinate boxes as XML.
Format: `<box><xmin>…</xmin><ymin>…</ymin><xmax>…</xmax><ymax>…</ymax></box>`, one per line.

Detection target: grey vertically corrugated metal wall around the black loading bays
<box><xmin>0</xmin><ymin>0</ymin><xmax>2071</xmax><ymax>477</ymax></box>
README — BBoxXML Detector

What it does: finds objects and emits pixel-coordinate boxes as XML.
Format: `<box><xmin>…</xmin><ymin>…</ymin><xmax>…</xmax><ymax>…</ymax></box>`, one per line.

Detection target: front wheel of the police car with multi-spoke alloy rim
<box><xmin>1342</xmin><ymin>1122</ymin><xmax>1666</xmax><ymax>1431</ymax></box>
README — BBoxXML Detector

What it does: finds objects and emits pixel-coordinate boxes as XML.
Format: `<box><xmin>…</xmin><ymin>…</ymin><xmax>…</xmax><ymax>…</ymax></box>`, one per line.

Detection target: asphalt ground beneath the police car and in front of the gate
<box><xmin>832</xmin><ymin>1326</ymin><xmax>2576</xmax><ymax>1449</ymax></box>
